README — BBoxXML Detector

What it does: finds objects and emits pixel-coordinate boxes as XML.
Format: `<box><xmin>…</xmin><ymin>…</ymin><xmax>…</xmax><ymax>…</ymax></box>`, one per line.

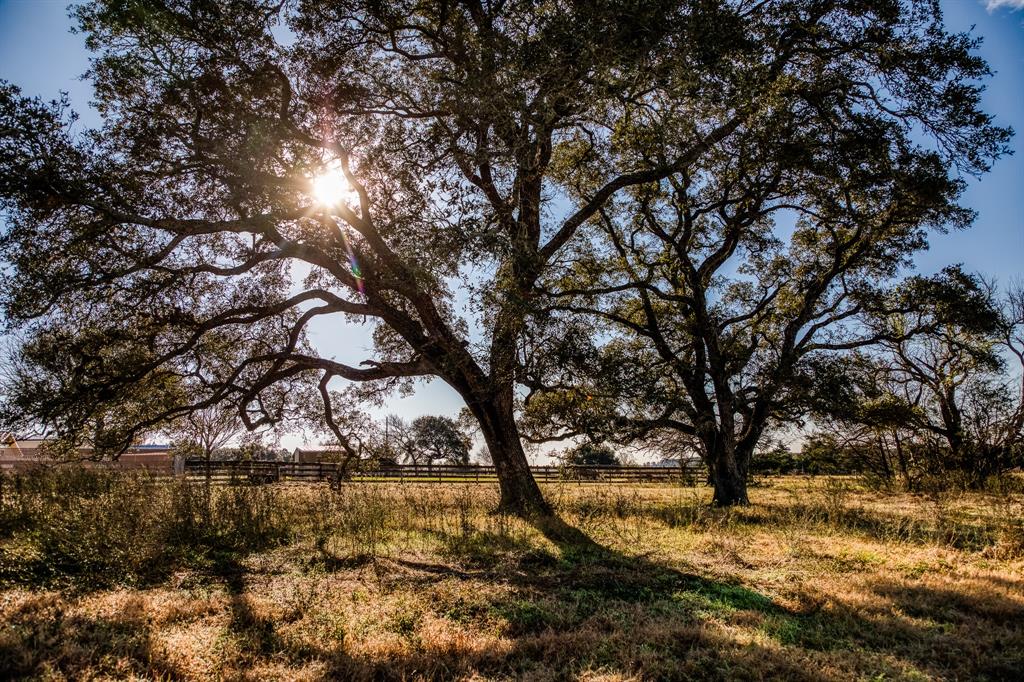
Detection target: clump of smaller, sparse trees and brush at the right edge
<box><xmin>798</xmin><ymin>273</ymin><xmax>1024</xmax><ymax>491</ymax></box>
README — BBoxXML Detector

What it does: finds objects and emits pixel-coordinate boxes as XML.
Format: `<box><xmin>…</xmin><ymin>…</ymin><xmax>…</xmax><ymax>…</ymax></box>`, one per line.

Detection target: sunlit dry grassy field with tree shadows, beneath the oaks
<box><xmin>0</xmin><ymin>476</ymin><xmax>1024</xmax><ymax>680</ymax></box>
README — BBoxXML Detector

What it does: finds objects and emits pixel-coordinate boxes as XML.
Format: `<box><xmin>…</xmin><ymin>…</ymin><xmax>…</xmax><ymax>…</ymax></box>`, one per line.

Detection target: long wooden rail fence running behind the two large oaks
<box><xmin>185</xmin><ymin>460</ymin><xmax>705</xmax><ymax>483</ymax></box>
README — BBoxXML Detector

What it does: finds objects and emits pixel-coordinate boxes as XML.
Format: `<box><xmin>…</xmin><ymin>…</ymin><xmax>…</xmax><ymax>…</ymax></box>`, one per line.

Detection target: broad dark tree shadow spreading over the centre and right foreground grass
<box><xmin>323</xmin><ymin>520</ymin><xmax>1024</xmax><ymax>680</ymax></box>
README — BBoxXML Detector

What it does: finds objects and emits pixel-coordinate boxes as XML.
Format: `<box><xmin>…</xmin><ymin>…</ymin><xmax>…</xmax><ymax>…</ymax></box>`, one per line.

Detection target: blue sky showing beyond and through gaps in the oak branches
<box><xmin>0</xmin><ymin>0</ymin><xmax>1024</xmax><ymax>450</ymax></box>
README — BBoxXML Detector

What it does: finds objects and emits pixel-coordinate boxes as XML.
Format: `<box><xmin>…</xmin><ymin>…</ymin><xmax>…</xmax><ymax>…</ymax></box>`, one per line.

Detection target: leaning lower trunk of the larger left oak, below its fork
<box><xmin>467</xmin><ymin>399</ymin><xmax>553</xmax><ymax>520</ymax></box>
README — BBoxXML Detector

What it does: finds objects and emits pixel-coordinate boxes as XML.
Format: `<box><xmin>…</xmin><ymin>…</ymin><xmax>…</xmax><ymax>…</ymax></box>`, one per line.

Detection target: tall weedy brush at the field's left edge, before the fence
<box><xmin>0</xmin><ymin>467</ymin><xmax>293</xmax><ymax>587</ymax></box>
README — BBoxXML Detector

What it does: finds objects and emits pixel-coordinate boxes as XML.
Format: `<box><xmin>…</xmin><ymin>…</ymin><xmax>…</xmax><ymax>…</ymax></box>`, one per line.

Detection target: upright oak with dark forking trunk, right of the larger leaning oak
<box><xmin>516</xmin><ymin>3</ymin><xmax>1009</xmax><ymax>505</ymax></box>
